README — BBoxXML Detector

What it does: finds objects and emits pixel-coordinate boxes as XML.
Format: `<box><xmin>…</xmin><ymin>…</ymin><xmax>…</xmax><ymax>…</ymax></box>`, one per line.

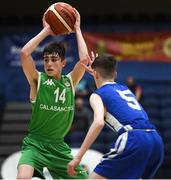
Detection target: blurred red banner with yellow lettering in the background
<box><xmin>83</xmin><ymin>32</ymin><xmax>171</xmax><ymax>63</ymax></box>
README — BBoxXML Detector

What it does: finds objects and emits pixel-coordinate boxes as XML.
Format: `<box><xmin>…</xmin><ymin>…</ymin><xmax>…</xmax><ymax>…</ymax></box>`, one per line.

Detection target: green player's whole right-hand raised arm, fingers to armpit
<box><xmin>71</xmin><ymin>9</ymin><xmax>88</xmax><ymax>87</ymax></box>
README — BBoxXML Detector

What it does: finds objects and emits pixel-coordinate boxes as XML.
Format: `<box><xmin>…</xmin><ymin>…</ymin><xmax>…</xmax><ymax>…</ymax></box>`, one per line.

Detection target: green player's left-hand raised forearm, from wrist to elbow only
<box><xmin>21</xmin><ymin>28</ymin><xmax>49</xmax><ymax>56</ymax></box>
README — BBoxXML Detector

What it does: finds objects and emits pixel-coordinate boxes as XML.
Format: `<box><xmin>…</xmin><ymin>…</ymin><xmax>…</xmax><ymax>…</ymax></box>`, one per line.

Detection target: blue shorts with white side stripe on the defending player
<box><xmin>94</xmin><ymin>130</ymin><xmax>164</xmax><ymax>179</ymax></box>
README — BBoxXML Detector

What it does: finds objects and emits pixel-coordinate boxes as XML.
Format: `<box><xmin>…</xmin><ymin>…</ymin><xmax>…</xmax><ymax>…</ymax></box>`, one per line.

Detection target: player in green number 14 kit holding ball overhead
<box><xmin>17</xmin><ymin>10</ymin><xmax>88</xmax><ymax>179</ymax></box>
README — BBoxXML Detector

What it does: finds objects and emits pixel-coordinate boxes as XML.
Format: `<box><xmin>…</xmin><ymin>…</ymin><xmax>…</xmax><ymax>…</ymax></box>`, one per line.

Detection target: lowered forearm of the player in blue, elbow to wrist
<box><xmin>76</xmin><ymin>121</ymin><xmax>104</xmax><ymax>159</ymax></box>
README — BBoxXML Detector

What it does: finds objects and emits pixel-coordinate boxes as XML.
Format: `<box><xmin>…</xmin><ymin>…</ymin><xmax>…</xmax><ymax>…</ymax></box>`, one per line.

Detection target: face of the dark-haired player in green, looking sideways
<box><xmin>43</xmin><ymin>53</ymin><xmax>66</xmax><ymax>77</ymax></box>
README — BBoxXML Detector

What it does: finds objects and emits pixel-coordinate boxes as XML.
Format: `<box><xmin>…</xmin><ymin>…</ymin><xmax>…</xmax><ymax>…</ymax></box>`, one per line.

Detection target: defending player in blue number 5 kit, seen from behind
<box><xmin>68</xmin><ymin>55</ymin><xmax>164</xmax><ymax>179</ymax></box>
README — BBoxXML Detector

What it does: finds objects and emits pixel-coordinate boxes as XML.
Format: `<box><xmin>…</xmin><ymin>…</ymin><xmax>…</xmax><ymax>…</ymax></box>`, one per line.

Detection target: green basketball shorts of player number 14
<box><xmin>18</xmin><ymin>134</ymin><xmax>88</xmax><ymax>179</ymax></box>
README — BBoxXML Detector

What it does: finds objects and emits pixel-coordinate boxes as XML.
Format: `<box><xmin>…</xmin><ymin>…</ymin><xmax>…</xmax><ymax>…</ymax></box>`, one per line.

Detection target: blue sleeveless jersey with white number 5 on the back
<box><xmin>95</xmin><ymin>82</ymin><xmax>155</xmax><ymax>131</ymax></box>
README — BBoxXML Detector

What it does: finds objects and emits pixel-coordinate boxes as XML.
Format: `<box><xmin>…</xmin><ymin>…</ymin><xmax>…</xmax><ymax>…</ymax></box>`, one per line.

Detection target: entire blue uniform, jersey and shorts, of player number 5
<box><xmin>94</xmin><ymin>82</ymin><xmax>164</xmax><ymax>179</ymax></box>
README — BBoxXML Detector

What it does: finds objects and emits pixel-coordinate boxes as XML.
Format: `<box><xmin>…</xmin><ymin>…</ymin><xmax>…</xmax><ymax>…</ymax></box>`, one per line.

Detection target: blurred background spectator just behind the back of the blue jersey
<box><xmin>126</xmin><ymin>76</ymin><xmax>142</xmax><ymax>102</ymax></box>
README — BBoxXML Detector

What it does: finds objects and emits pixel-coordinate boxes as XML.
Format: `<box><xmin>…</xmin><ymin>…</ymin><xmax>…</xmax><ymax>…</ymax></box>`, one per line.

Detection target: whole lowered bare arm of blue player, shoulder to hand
<box><xmin>68</xmin><ymin>94</ymin><xmax>105</xmax><ymax>175</ymax></box>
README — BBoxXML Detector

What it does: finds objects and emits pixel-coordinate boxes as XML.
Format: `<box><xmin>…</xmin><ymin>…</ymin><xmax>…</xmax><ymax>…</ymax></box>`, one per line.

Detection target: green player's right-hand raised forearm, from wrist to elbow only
<box><xmin>76</xmin><ymin>28</ymin><xmax>88</xmax><ymax>60</ymax></box>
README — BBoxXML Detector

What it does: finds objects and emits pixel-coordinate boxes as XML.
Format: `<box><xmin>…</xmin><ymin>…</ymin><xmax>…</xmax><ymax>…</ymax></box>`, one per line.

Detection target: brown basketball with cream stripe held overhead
<box><xmin>45</xmin><ymin>2</ymin><xmax>76</xmax><ymax>35</ymax></box>
